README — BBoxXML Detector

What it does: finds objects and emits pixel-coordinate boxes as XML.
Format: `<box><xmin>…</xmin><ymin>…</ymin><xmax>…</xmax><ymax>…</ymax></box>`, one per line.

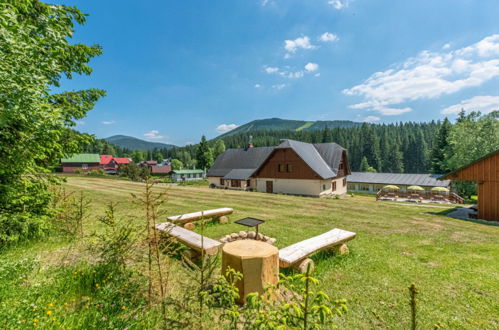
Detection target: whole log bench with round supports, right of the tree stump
<box><xmin>279</xmin><ymin>228</ymin><xmax>356</xmax><ymax>273</ymax></box>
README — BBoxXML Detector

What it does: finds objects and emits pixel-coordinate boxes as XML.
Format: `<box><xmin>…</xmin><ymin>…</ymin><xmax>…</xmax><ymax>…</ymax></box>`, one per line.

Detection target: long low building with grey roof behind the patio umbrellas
<box><xmin>348</xmin><ymin>172</ymin><xmax>450</xmax><ymax>194</ymax></box>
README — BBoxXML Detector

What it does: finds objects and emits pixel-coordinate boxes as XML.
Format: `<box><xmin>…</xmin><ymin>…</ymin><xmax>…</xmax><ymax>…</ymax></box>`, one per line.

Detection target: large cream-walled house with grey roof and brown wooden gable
<box><xmin>207</xmin><ymin>140</ymin><xmax>350</xmax><ymax>197</ymax></box>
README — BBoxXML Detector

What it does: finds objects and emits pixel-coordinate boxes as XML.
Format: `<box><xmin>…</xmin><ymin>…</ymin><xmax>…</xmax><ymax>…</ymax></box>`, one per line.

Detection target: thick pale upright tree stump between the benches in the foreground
<box><xmin>222</xmin><ymin>240</ymin><xmax>279</xmax><ymax>304</ymax></box>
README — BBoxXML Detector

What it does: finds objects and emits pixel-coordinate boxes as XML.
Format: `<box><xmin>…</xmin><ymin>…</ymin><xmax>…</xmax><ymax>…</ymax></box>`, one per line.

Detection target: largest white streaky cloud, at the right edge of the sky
<box><xmin>343</xmin><ymin>34</ymin><xmax>499</xmax><ymax>115</ymax></box>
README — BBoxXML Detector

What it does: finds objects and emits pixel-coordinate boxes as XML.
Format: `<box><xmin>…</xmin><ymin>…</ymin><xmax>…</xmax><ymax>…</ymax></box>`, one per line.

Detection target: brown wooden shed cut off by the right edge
<box><xmin>441</xmin><ymin>150</ymin><xmax>499</xmax><ymax>221</ymax></box>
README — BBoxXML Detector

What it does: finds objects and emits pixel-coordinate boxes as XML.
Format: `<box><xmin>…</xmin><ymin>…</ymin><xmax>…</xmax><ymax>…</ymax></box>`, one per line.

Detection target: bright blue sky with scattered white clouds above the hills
<box><xmin>56</xmin><ymin>0</ymin><xmax>499</xmax><ymax>145</ymax></box>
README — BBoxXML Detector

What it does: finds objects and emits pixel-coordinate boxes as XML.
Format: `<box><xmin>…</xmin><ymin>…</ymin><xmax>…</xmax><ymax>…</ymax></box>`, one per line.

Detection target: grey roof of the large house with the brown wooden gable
<box><xmin>207</xmin><ymin>140</ymin><xmax>345</xmax><ymax>180</ymax></box>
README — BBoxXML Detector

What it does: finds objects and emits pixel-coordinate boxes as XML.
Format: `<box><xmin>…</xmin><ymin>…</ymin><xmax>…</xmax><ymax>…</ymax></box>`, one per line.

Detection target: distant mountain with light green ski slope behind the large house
<box><xmin>219</xmin><ymin>118</ymin><xmax>362</xmax><ymax>137</ymax></box>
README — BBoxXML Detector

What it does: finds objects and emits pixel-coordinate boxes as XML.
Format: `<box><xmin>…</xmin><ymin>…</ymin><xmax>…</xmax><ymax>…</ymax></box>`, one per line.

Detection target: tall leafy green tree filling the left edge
<box><xmin>0</xmin><ymin>0</ymin><xmax>105</xmax><ymax>246</ymax></box>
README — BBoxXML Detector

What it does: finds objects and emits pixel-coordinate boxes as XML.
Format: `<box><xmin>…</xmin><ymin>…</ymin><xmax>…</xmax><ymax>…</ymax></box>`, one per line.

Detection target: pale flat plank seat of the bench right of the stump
<box><xmin>279</xmin><ymin>228</ymin><xmax>356</xmax><ymax>268</ymax></box>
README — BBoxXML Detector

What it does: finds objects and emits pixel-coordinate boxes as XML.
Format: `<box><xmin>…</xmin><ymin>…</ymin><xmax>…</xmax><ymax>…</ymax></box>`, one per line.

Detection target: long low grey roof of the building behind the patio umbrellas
<box><xmin>347</xmin><ymin>172</ymin><xmax>450</xmax><ymax>187</ymax></box>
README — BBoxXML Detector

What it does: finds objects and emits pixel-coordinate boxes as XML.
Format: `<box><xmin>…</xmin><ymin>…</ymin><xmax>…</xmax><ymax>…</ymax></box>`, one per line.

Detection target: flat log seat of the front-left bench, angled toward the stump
<box><xmin>156</xmin><ymin>222</ymin><xmax>222</xmax><ymax>255</ymax></box>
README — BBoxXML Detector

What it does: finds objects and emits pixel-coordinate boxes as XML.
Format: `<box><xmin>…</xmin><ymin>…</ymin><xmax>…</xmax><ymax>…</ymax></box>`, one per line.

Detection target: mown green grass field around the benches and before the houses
<box><xmin>0</xmin><ymin>177</ymin><xmax>499</xmax><ymax>329</ymax></box>
